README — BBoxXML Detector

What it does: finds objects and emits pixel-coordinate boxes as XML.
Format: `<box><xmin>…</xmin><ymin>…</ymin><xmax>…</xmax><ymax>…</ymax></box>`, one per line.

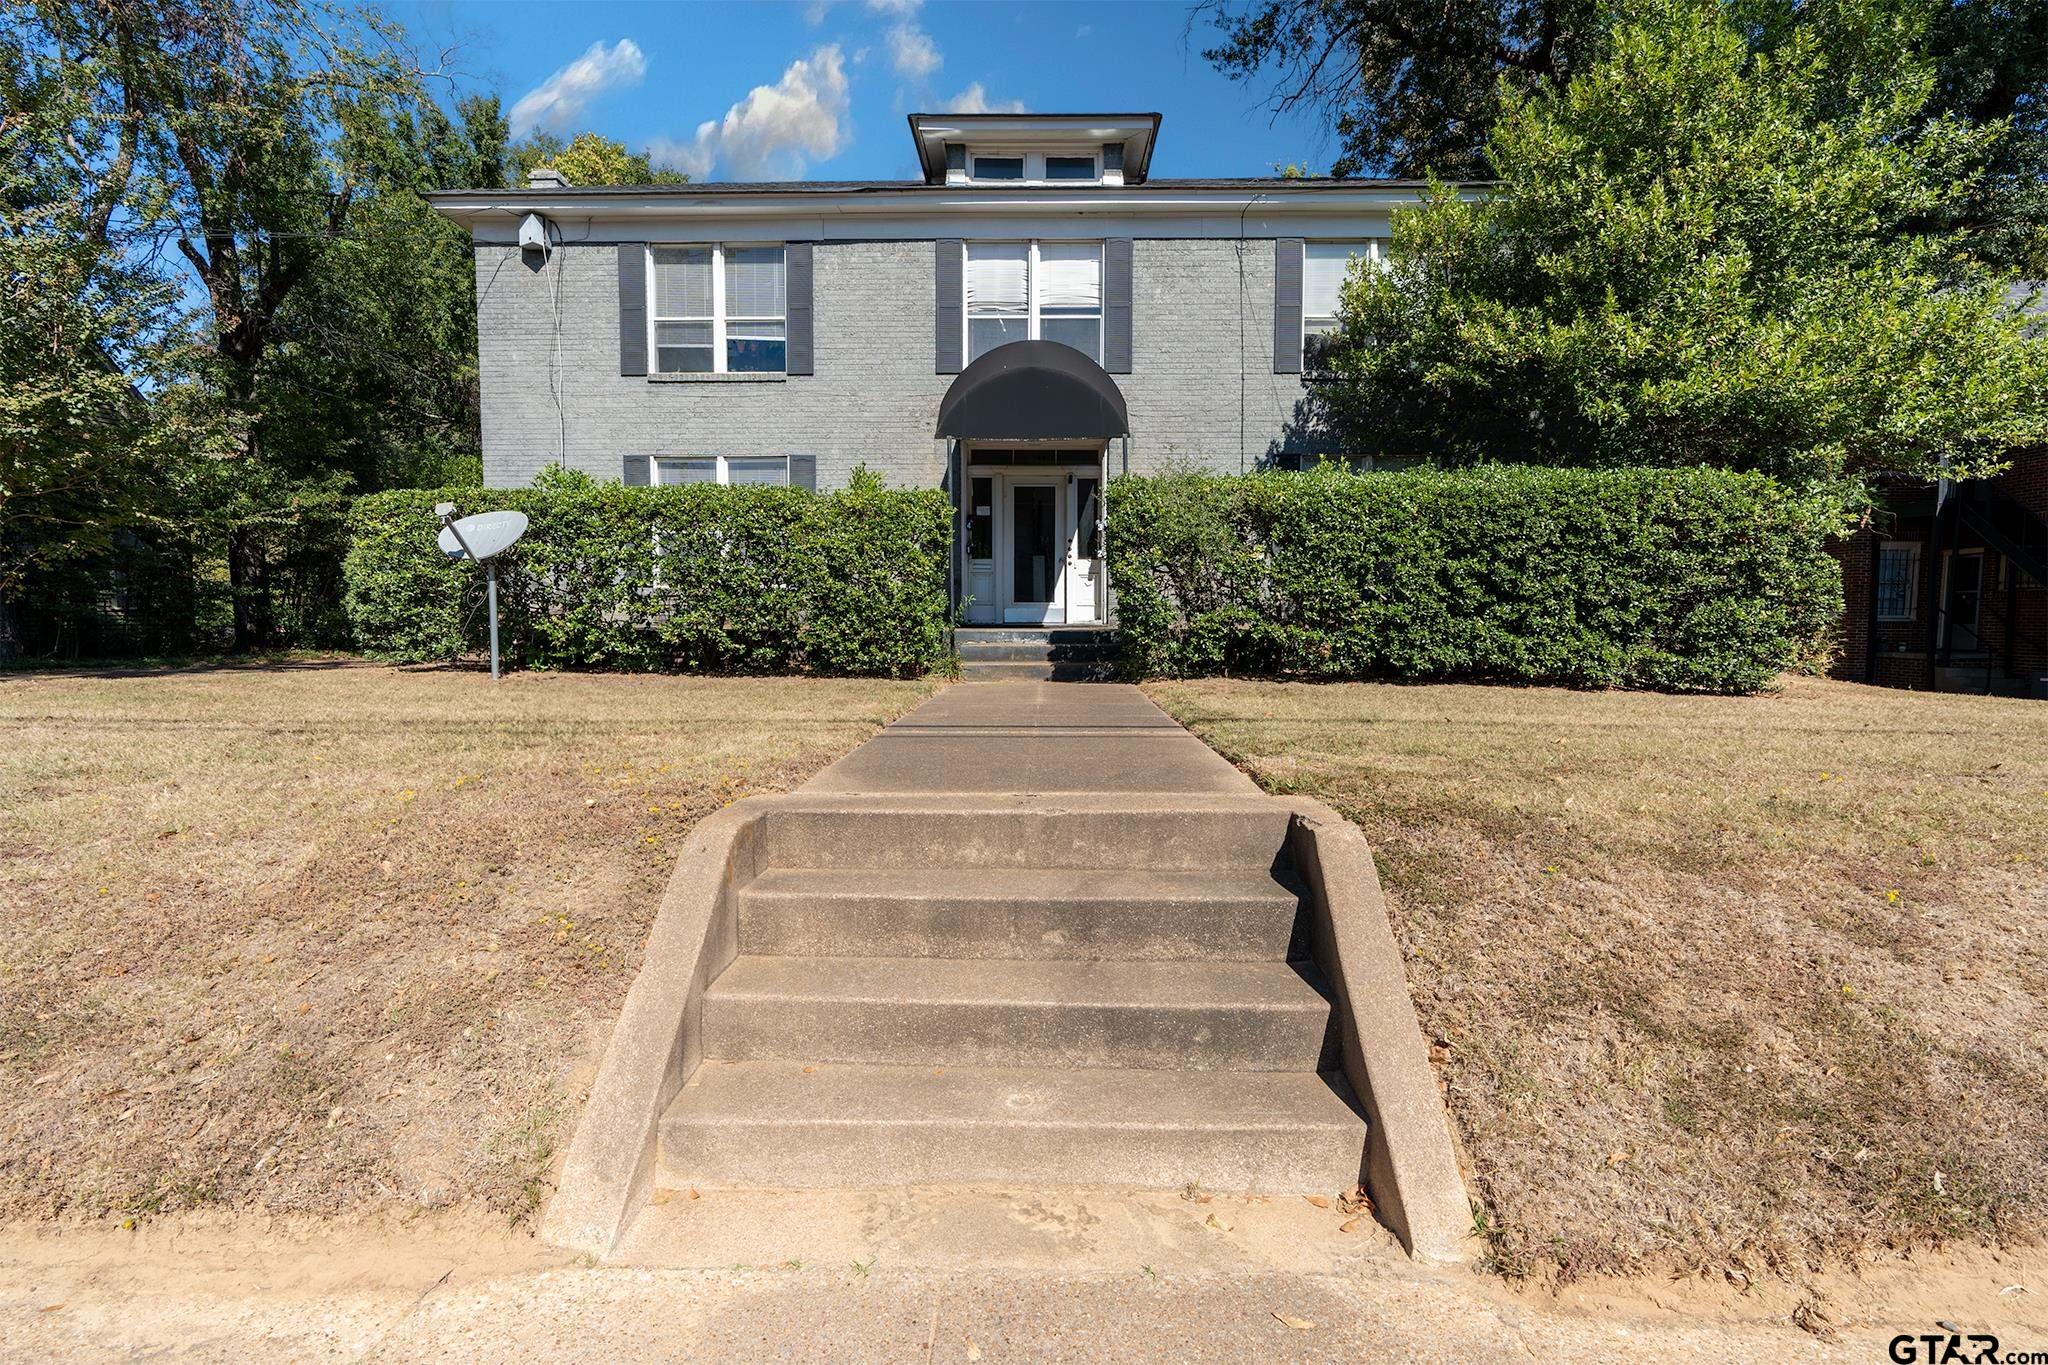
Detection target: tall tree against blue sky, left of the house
<box><xmin>8</xmin><ymin>0</ymin><xmax>464</xmax><ymax>647</ymax></box>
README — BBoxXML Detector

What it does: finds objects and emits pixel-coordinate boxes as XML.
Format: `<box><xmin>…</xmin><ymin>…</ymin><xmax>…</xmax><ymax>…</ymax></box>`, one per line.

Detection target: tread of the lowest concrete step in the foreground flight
<box><xmin>666</xmin><ymin>1062</ymin><xmax>1366</xmax><ymax>1146</ymax></box>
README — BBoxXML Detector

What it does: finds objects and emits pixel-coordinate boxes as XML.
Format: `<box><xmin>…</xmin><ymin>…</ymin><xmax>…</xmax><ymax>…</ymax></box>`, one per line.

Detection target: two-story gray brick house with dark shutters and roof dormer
<box><xmin>432</xmin><ymin>115</ymin><xmax>1421</xmax><ymax>624</ymax></box>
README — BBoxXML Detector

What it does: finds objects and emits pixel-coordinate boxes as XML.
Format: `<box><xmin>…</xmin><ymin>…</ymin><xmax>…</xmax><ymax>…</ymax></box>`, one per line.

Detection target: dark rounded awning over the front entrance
<box><xmin>938</xmin><ymin>342</ymin><xmax>1130</xmax><ymax>440</ymax></box>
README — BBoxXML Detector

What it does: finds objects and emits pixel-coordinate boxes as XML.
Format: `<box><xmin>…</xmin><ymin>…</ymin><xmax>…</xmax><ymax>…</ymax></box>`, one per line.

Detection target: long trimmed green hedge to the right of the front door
<box><xmin>1106</xmin><ymin>467</ymin><xmax>1841</xmax><ymax>692</ymax></box>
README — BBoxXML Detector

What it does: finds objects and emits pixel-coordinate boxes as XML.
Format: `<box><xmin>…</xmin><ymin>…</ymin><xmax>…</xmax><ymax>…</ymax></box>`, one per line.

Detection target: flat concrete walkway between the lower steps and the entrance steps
<box><xmin>803</xmin><ymin>681</ymin><xmax>1257</xmax><ymax>796</ymax></box>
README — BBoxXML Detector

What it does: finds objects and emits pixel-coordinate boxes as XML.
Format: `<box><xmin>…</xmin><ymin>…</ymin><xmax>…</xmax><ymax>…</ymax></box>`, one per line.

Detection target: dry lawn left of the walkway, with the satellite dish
<box><xmin>0</xmin><ymin>661</ymin><xmax>930</xmax><ymax>1218</ymax></box>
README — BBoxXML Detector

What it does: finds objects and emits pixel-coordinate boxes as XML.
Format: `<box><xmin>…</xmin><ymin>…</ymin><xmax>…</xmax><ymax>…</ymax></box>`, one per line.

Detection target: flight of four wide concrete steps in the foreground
<box><xmin>655</xmin><ymin>802</ymin><xmax>1366</xmax><ymax>1193</ymax></box>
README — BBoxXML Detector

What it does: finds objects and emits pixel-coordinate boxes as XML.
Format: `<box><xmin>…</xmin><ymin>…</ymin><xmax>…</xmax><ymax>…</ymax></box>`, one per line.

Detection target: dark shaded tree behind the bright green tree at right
<box><xmin>1194</xmin><ymin>0</ymin><xmax>2048</xmax><ymax>278</ymax></box>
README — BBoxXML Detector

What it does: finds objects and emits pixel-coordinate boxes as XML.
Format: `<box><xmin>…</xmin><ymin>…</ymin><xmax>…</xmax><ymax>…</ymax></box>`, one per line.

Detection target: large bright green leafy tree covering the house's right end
<box><xmin>1313</xmin><ymin>0</ymin><xmax>2048</xmax><ymax>483</ymax></box>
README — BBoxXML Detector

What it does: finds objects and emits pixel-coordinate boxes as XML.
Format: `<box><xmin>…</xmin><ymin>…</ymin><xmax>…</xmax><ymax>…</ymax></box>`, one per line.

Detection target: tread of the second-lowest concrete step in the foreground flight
<box><xmin>707</xmin><ymin>956</ymin><xmax>1329</xmax><ymax>1015</ymax></box>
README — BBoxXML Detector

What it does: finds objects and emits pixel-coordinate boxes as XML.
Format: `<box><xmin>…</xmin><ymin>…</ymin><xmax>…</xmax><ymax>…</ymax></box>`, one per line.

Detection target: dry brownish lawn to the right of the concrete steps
<box><xmin>1149</xmin><ymin>677</ymin><xmax>2048</xmax><ymax>1283</ymax></box>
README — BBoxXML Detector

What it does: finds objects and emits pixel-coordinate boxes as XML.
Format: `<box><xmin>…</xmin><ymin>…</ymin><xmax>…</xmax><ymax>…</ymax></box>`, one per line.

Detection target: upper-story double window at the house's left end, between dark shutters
<box><xmin>647</xmin><ymin>244</ymin><xmax>786</xmax><ymax>375</ymax></box>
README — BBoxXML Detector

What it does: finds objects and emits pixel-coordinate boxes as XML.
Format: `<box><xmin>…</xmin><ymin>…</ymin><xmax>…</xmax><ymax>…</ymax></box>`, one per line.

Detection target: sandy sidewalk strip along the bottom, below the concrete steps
<box><xmin>0</xmin><ymin>1189</ymin><xmax>1990</xmax><ymax>1365</ymax></box>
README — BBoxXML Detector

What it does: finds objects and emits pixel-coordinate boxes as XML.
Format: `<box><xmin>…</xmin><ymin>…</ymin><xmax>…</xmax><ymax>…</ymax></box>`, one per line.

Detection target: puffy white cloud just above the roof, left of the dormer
<box><xmin>647</xmin><ymin>43</ymin><xmax>848</xmax><ymax>180</ymax></box>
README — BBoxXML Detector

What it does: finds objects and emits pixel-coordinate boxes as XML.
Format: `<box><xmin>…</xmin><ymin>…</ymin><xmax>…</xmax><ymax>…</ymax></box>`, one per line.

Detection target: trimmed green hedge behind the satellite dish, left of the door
<box><xmin>342</xmin><ymin>473</ymin><xmax>952</xmax><ymax>675</ymax></box>
